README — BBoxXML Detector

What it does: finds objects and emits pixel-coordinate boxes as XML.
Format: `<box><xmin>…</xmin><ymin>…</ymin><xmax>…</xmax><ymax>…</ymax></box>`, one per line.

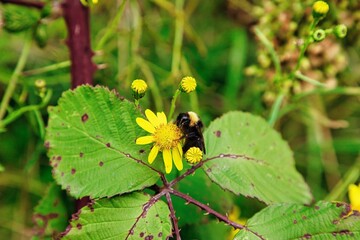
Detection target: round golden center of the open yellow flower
<box><xmin>154</xmin><ymin>123</ymin><xmax>182</xmax><ymax>151</ymax></box>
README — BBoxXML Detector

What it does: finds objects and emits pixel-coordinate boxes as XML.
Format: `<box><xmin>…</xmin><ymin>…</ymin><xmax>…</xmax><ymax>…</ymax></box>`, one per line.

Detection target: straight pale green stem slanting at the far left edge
<box><xmin>0</xmin><ymin>31</ymin><xmax>32</xmax><ymax>120</ymax></box>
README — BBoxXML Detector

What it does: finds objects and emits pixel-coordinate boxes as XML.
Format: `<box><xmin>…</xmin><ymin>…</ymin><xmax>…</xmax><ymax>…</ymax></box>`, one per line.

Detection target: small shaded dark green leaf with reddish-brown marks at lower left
<box><xmin>33</xmin><ymin>183</ymin><xmax>68</xmax><ymax>239</ymax></box>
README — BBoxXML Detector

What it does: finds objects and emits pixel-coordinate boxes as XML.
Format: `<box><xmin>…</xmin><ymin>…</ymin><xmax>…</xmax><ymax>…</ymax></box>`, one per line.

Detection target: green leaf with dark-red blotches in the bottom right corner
<box><xmin>234</xmin><ymin>201</ymin><xmax>360</xmax><ymax>240</ymax></box>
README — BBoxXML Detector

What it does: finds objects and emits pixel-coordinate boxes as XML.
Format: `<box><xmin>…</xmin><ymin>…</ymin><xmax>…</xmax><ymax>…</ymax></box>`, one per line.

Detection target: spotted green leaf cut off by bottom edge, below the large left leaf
<box><xmin>64</xmin><ymin>192</ymin><xmax>172</xmax><ymax>240</ymax></box>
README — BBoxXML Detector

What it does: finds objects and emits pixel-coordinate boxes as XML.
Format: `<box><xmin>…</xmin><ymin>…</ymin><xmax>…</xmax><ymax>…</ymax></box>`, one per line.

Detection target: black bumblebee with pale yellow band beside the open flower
<box><xmin>176</xmin><ymin>112</ymin><xmax>206</xmax><ymax>154</ymax></box>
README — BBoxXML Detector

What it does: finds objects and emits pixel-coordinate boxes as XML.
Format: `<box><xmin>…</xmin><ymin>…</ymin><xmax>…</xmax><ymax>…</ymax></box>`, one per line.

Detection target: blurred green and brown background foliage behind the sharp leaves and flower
<box><xmin>0</xmin><ymin>0</ymin><xmax>360</xmax><ymax>239</ymax></box>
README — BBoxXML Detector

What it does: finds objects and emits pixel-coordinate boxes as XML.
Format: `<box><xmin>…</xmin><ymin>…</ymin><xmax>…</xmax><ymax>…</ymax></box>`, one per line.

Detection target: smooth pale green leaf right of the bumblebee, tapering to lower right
<box><xmin>204</xmin><ymin>112</ymin><xmax>312</xmax><ymax>204</ymax></box>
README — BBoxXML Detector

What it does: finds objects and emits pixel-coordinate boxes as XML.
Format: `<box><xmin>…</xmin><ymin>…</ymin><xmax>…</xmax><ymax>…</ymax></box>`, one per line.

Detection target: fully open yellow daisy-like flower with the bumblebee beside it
<box><xmin>136</xmin><ymin>109</ymin><xmax>183</xmax><ymax>173</ymax></box>
